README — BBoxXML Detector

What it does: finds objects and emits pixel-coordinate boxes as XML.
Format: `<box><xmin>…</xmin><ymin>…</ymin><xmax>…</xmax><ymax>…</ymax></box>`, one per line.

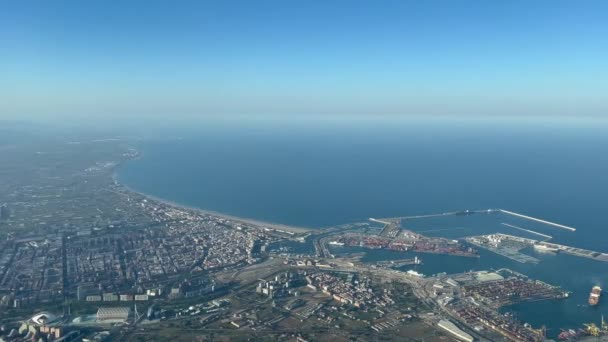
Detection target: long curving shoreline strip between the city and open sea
<box><xmin>111</xmin><ymin>170</ymin><xmax>314</xmax><ymax>234</ymax></box>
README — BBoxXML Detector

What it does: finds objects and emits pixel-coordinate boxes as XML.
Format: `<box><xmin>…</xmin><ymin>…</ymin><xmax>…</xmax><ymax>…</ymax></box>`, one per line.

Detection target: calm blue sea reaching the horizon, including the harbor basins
<box><xmin>118</xmin><ymin>118</ymin><xmax>608</xmax><ymax>337</ymax></box>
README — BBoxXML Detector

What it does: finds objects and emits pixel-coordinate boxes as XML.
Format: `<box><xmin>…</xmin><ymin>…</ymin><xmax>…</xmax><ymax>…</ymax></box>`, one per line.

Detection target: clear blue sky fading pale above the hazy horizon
<box><xmin>0</xmin><ymin>0</ymin><xmax>608</xmax><ymax>119</ymax></box>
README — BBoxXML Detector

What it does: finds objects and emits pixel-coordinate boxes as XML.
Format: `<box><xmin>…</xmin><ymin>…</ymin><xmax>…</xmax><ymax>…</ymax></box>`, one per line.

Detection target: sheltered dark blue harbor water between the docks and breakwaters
<box><xmin>360</xmin><ymin>211</ymin><xmax>608</xmax><ymax>340</ymax></box>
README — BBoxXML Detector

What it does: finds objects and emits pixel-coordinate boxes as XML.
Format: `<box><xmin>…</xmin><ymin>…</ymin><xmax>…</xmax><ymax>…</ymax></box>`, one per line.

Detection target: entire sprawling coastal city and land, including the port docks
<box><xmin>0</xmin><ymin>134</ymin><xmax>607</xmax><ymax>341</ymax></box>
